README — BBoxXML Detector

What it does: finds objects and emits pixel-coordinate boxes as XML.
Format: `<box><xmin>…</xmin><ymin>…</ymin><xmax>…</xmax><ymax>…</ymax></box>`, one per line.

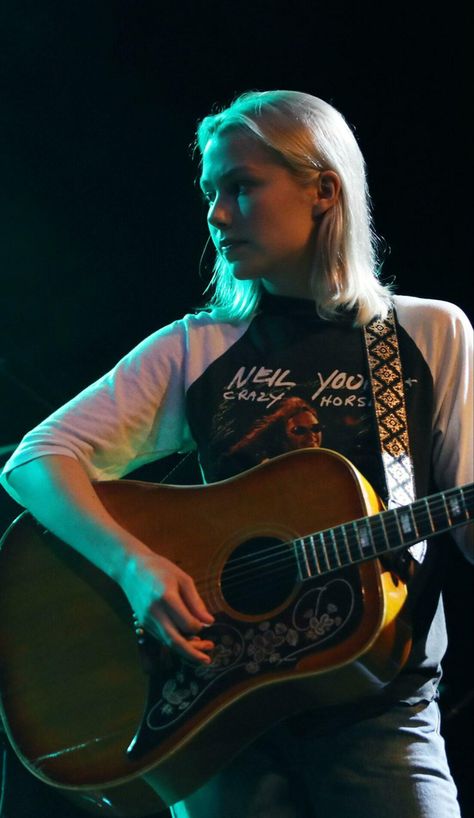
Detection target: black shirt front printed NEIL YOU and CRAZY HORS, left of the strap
<box><xmin>187</xmin><ymin>297</ymin><xmax>422</xmax><ymax>504</ymax></box>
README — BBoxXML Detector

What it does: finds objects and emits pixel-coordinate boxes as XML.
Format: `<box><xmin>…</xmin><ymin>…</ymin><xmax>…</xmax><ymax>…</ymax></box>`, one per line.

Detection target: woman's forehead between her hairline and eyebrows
<box><xmin>201</xmin><ymin>129</ymin><xmax>281</xmax><ymax>184</ymax></box>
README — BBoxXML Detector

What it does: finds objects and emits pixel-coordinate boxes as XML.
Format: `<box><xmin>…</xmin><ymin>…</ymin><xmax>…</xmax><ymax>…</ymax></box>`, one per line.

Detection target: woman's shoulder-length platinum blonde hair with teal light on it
<box><xmin>196</xmin><ymin>91</ymin><xmax>391</xmax><ymax>325</ymax></box>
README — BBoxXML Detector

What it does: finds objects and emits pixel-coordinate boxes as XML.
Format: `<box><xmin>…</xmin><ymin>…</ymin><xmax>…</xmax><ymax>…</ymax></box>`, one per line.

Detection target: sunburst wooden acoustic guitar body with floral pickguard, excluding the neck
<box><xmin>0</xmin><ymin>449</ymin><xmax>410</xmax><ymax>816</ymax></box>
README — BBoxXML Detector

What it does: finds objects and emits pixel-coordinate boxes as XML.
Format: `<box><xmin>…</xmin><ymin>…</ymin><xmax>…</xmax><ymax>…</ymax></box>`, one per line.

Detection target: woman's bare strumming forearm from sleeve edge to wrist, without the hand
<box><xmin>4</xmin><ymin>455</ymin><xmax>148</xmax><ymax>583</ymax></box>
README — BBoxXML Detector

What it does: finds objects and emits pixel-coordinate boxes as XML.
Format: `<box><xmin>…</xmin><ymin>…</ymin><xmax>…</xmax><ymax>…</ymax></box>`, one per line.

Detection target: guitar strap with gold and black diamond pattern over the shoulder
<box><xmin>364</xmin><ymin>309</ymin><xmax>426</xmax><ymax>563</ymax></box>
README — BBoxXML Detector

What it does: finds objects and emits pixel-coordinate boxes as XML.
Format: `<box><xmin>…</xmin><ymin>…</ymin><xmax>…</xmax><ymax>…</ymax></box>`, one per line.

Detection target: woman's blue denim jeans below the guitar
<box><xmin>171</xmin><ymin>702</ymin><xmax>460</xmax><ymax>818</ymax></box>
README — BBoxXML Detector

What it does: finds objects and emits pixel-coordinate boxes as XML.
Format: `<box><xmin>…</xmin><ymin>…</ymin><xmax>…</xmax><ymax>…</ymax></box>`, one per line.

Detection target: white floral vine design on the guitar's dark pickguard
<box><xmin>146</xmin><ymin>578</ymin><xmax>355</xmax><ymax>731</ymax></box>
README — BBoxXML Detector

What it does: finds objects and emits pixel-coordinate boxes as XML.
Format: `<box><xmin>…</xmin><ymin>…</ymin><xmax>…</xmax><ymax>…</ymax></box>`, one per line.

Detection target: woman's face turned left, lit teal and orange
<box><xmin>201</xmin><ymin>130</ymin><xmax>316</xmax><ymax>298</ymax></box>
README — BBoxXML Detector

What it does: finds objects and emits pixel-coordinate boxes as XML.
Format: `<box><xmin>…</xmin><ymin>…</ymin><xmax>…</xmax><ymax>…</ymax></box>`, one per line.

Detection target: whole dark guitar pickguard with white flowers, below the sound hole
<box><xmin>128</xmin><ymin>570</ymin><xmax>362</xmax><ymax>757</ymax></box>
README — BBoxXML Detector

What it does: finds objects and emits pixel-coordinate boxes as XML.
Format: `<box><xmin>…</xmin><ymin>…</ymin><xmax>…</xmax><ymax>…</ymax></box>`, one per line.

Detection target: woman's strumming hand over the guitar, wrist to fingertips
<box><xmin>121</xmin><ymin>551</ymin><xmax>214</xmax><ymax>664</ymax></box>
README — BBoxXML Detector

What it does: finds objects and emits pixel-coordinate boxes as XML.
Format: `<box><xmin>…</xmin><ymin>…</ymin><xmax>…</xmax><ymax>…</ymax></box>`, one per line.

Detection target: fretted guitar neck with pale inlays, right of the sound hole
<box><xmin>293</xmin><ymin>483</ymin><xmax>474</xmax><ymax>580</ymax></box>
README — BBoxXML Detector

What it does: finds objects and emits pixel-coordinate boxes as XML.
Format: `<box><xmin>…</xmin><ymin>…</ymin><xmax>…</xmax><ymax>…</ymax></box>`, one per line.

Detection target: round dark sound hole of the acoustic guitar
<box><xmin>221</xmin><ymin>537</ymin><xmax>297</xmax><ymax>615</ymax></box>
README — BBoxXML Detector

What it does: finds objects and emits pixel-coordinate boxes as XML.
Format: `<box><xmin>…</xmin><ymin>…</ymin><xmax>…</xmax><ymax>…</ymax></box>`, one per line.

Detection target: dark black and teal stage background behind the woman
<box><xmin>0</xmin><ymin>0</ymin><xmax>473</xmax><ymax>818</ymax></box>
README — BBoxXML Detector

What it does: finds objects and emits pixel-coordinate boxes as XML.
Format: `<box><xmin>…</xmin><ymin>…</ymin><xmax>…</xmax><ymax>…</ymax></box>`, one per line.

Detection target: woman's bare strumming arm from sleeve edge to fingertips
<box><xmin>7</xmin><ymin>455</ymin><xmax>213</xmax><ymax>662</ymax></box>
